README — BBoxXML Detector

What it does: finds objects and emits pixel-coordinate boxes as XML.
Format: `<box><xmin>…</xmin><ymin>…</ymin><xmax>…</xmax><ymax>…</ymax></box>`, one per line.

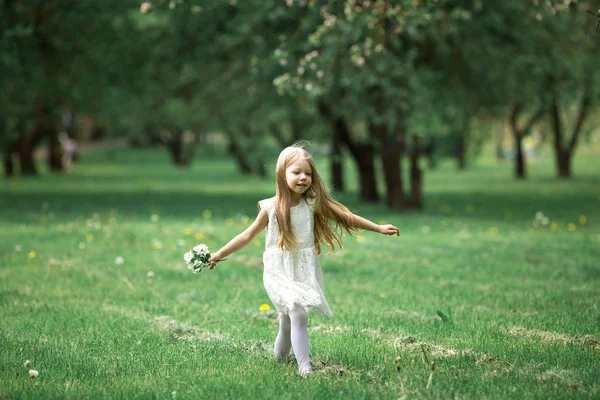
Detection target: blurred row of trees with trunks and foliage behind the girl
<box><xmin>0</xmin><ymin>0</ymin><xmax>600</xmax><ymax>210</ymax></box>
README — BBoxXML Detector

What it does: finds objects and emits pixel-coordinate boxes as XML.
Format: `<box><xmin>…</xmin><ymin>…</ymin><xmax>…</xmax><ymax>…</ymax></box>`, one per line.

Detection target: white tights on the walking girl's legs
<box><xmin>275</xmin><ymin>305</ymin><xmax>312</xmax><ymax>374</ymax></box>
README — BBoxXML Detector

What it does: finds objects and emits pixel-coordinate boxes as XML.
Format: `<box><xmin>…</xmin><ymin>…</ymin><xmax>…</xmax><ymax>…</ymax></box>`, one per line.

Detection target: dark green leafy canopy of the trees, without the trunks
<box><xmin>0</xmin><ymin>0</ymin><xmax>600</xmax><ymax>177</ymax></box>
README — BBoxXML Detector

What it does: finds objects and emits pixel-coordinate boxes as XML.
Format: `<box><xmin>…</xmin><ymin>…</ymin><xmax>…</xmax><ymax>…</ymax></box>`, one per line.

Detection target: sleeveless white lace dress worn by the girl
<box><xmin>258</xmin><ymin>197</ymin><xmax>333</xmax><ymax>317</ymax></box>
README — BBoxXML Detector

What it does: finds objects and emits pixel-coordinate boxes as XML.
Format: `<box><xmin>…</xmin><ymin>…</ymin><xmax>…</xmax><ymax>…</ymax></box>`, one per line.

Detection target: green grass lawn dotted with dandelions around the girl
<box><xmin>0</xmin><ymin>142</ymin><xmax>600</xmax><ymax>399</ymax></box>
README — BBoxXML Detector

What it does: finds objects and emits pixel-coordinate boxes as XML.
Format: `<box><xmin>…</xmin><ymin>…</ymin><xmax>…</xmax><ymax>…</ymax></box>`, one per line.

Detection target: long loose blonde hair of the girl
<box><xmin>275</xmin><ymin>143</ymin><xmax>358</xmax><ymax>253</ymax></box>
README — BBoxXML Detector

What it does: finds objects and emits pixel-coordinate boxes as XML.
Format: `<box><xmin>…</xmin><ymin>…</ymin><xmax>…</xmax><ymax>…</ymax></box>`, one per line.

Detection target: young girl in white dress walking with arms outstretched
<box><xmin>209</xmin><ymin>144</ymin><xmax>399</xmax><ymax>375</ymax></box>
